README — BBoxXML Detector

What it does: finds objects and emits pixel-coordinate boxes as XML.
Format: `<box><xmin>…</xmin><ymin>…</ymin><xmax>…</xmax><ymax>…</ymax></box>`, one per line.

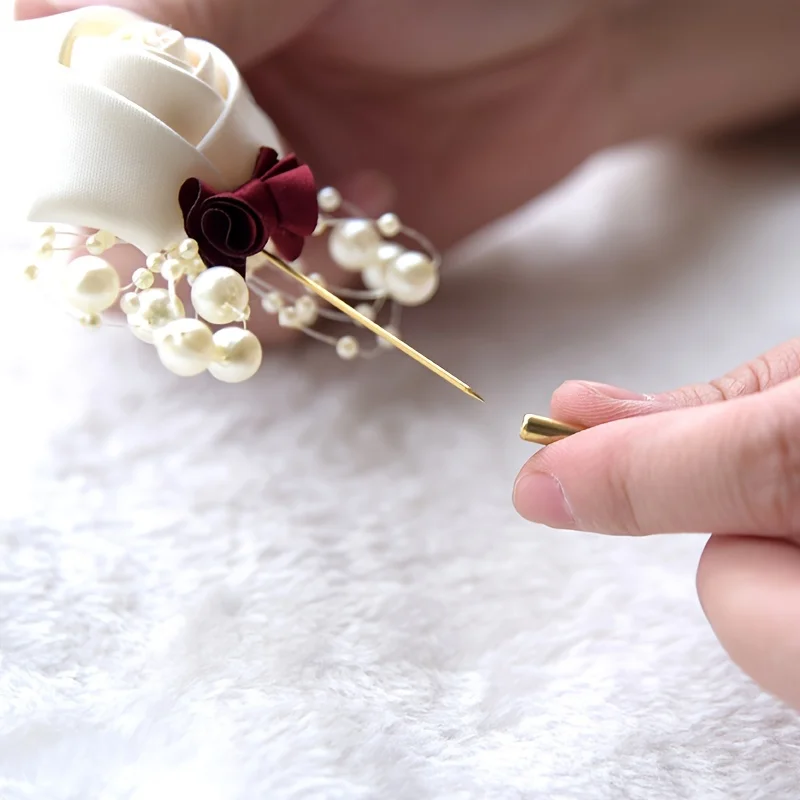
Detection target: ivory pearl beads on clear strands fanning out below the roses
<box><xmin>23</xmin><ymin>187</ymin><xmax>440</xmax><ymax>383</ymax></box>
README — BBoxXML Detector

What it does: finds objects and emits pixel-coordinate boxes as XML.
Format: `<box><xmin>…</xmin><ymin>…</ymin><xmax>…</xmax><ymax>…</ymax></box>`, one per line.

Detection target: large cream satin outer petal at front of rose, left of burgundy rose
<box><xmin>10</xmin><ymin>65</ymin><xmax>221</xmax><ymax>253</ymax></box>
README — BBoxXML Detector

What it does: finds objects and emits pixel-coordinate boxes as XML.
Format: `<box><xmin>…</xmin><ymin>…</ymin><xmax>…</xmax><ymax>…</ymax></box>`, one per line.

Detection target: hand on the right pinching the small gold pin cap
<box><xmin>514</xmin><ymin>340</ymin><xmax>800</xmax><ymax>709</ymax></box>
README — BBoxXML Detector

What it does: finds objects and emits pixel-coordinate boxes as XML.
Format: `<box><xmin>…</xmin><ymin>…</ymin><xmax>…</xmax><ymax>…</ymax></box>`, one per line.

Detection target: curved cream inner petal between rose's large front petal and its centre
<box><xmin>70</xmin><ymin>38</ymin><xmax>225</xmax><ymax>146</ymax></box>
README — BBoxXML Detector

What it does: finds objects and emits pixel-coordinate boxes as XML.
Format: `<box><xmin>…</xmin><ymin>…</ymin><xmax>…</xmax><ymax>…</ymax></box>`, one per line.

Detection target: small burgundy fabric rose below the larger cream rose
<box><xmin>178</xmin><ymin>147</ymin><xmax>319</xmax><ymax>276</ymax></box>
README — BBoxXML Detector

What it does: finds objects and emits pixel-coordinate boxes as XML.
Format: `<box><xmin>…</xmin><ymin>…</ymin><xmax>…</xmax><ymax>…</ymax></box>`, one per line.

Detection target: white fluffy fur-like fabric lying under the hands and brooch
<box><xmin>0</xmin><ymin>141</ymin><xmax>800</xmax><ymax>800</ymax></box>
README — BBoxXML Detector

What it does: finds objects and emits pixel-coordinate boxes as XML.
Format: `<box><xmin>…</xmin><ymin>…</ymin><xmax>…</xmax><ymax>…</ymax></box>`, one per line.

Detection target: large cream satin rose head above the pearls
<box><xmin>0</xmin><ymin>6</ymin><xmax>281</xmax><ymax>253</ymax></box>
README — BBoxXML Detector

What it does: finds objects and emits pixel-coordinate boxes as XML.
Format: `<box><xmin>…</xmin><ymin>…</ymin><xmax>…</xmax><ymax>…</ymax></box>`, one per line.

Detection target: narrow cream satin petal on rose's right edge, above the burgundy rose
<box><xmin>188</xmin><ymin>39</ymin><xmax>283</xmax><ymax>187</ymax></box>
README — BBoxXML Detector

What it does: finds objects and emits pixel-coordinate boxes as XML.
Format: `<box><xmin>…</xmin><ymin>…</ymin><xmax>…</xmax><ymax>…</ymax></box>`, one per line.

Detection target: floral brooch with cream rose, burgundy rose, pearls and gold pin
<box><xmin>10</xmin><ymin>7</ymin><xmax>480</xmax><ymax>399</ymax></box>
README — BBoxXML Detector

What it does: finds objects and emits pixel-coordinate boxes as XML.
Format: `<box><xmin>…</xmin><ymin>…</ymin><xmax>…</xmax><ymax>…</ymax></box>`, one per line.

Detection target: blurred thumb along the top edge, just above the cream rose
<box><xmin>14</xmin><ymin>0</ymin><xmax>331</xmax><ymax>67</ymax></box>
